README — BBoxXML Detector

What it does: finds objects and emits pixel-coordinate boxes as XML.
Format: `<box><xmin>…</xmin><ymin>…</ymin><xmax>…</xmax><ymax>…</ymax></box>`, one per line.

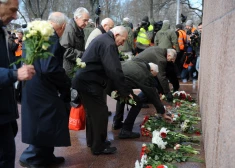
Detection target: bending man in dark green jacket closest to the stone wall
<box><xmin>133</xmin><ymin>46</ymin><xmax>176</xmax><ymax>101</ymax></box>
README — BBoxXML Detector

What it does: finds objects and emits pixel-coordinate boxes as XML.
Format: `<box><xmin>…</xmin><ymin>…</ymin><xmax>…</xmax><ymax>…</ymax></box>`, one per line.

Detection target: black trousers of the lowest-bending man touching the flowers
<box><xmin>114</xmin><ymin>95</ymin><xmax>143</xmax><ymax>131</ymax></box>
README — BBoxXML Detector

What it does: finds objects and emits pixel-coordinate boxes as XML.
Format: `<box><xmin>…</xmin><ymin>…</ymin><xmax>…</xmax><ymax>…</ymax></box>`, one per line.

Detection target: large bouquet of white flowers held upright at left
<box><xmin>16</xmin><ymin>20</ymin><xmax>54</xmax><ymax>65</ymax></box>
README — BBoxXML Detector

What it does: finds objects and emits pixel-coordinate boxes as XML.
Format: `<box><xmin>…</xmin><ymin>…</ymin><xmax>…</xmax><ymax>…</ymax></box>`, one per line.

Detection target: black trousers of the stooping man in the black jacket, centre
<box><xmin>80</xmin><ymin>90</ymin><xmax>108</xmax><ymax>152</ymax></box>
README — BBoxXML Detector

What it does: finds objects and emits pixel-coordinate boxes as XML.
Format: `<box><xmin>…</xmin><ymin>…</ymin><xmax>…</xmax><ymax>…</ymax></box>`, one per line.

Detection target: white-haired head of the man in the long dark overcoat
<box><xmin>48</xmin><ymin>12</ymin><xmax>68</xmax><ymax>37</ymax></box>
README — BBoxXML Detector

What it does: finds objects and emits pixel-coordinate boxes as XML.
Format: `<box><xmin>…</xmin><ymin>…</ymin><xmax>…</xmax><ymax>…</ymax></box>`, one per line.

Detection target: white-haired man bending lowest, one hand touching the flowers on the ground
<box><xmin>113</xmin><ymin>60</ymin><xmax>171</xmax><ymax>139</ymax></box>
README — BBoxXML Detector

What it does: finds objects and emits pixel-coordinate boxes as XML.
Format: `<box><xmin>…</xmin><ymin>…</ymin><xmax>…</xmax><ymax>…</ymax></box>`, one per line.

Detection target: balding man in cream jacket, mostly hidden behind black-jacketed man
<box><xmin>85</xmin><ymin>18</ymin><xmax>114</xmax><ymax>49</ymax></box>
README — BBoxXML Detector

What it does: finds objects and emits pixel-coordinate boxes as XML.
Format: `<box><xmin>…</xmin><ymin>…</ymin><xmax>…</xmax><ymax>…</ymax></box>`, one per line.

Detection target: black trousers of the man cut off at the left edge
<box><xmin>0</xmin><ymin>121</ymin><xmax>16</xmax><ymax>168</ymax></box>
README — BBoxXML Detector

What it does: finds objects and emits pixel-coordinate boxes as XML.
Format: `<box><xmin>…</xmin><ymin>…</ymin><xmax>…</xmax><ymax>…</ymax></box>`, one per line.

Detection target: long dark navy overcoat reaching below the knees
<box><xmin>21</xmin><ymin>32</ymin><xmax>71</xmax><ymax>147</ymax></box>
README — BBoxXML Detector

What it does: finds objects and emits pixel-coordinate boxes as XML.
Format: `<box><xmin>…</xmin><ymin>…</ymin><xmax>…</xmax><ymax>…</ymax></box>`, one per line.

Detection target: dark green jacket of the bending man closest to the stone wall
<box><xmin>132</xmin><ymin>46</ymin><xmax>170</xmax><ymax>94</ymax></box>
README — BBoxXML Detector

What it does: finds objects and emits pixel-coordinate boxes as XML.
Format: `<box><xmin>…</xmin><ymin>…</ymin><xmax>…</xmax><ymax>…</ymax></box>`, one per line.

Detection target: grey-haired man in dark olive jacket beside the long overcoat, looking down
<box><xmin>60</xmin><ymin>7</ymin><xmax>90</xmax><ymax>76</ymax></box>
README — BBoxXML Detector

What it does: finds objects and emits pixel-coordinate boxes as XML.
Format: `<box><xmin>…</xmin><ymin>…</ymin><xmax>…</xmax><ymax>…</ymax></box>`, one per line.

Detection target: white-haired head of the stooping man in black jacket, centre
<box><xmin>110</xmin><ymin>26</ymin><xmax>128</xmax><ymax>46</ymax></box>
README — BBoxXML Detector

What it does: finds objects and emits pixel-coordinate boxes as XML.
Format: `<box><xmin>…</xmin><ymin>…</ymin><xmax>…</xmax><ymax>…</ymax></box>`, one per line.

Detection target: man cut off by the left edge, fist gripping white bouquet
<box><xmin>0</xmin><ymin>0</ymin><xmax>35</xmax><ymax>168</ymax></box>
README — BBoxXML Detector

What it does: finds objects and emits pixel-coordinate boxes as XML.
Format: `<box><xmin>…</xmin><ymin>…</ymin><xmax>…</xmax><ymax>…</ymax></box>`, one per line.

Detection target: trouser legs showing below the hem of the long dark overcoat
<box><xmin>20</xmin><ymin>145</ymin><xmax>55</xmax><ymax>165</ymax></box>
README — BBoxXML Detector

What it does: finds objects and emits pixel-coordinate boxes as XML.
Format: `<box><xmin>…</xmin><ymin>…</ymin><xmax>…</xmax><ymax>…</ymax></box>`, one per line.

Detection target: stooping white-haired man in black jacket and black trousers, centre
<box><xmin>72</xmin><ymin>26</ymin><xmax>131</xmax><ymax>155</ymax></box>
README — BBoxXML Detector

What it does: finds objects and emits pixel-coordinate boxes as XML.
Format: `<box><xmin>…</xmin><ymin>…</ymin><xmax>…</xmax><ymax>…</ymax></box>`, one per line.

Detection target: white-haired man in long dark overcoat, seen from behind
<box><xmin>20</xmin><ymin>12</ymin><xmax>71</xmax><ymax>167</ymax></box>
